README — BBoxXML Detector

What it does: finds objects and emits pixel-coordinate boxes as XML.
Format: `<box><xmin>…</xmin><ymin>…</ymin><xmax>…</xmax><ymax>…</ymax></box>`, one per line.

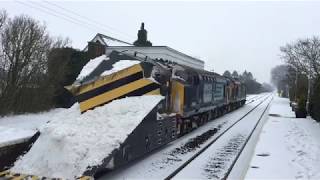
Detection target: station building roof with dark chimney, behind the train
<box><xmin>85</xmin><ymin>23</ymin><xmax>204</xmax><ymax>69</ymax></box>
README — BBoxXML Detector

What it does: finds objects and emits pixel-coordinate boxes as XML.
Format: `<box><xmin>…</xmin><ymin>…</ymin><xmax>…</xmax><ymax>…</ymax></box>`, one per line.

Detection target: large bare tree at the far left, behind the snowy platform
<box><xmin>0</xmin><ymin>15</ymin><xmax>68</xmax><ymax>114</ymax></box>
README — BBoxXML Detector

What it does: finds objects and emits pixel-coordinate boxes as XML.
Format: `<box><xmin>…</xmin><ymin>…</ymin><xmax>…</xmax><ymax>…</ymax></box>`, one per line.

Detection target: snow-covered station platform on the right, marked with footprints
<box><xmin>246</xmin><ymin>97</ymin><xmax>320</xmax><ymax>179</ymax></box>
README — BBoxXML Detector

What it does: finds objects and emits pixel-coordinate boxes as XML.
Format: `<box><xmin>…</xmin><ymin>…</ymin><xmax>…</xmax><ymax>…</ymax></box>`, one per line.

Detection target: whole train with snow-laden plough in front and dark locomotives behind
<box><xmin>0</xmin><ymin>48</ymin><xmax>246</xmax><ymax>179</ymax></box>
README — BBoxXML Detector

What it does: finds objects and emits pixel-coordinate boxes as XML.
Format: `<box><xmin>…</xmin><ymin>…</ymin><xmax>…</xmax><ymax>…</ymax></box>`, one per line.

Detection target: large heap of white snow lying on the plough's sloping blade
<box><xmin>11</xmin><ymin>95</ymin><xmax>163</xmax><ymax>179</ymax></box>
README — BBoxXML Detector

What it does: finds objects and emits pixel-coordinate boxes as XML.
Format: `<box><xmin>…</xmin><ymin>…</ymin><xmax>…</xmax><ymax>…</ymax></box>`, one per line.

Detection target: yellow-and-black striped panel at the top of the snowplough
<box><xmin>65</xmin><ymin>64</ymin><xmax>160</xmax><ymax>113</ymax></box>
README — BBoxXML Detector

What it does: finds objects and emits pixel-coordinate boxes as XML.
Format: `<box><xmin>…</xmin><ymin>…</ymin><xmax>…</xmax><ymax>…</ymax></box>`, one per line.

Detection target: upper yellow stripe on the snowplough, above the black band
<box><xmin>77</xmin><ymin>64</ymin><xmax>142</xmax><ymax>95</ymax></box>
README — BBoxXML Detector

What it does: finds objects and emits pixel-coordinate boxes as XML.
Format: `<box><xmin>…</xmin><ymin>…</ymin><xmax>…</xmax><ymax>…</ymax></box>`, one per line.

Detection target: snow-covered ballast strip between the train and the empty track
<box><xmin>98</xmin><ymin>94</ymin><xmax>270</xmax><ymax>179</ymax></box>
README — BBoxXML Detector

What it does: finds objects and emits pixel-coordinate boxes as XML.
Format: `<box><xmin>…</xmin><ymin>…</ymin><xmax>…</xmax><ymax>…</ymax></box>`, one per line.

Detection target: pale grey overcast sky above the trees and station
<box><xmin>0</xmin><ymin>0</ymin><xmax>320</xmax><ymax>82</ymax></box>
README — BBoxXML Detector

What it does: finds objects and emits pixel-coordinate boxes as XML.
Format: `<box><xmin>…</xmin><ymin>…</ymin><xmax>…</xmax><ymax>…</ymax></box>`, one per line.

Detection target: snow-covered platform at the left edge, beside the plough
<box><xmin>0</xmin><ymin>108</ymin><xmax>64</xmax><ymax>147</ymax></box>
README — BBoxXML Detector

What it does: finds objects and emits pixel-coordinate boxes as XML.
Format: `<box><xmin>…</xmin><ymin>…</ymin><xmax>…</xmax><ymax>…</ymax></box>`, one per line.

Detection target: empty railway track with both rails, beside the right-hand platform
<box><xmin>165</xmin><ymin>96</ymin><xmax>272</xmax><ymax>179</ymax></box>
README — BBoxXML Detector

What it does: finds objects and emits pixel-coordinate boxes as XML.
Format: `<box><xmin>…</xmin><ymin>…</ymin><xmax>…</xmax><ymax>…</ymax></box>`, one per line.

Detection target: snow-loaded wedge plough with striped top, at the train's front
<box><xmin>0</xmin><ymin>52</ymin><xmax>176</xmax><ymax>179</ymax></box>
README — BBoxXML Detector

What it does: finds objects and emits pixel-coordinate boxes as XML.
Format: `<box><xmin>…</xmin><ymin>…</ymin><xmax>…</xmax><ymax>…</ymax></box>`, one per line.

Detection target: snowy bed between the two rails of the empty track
<box><xmin>173</xmin><ymin>95</ymin><xmax>271</xmax><ymax>179</ymax></box>
